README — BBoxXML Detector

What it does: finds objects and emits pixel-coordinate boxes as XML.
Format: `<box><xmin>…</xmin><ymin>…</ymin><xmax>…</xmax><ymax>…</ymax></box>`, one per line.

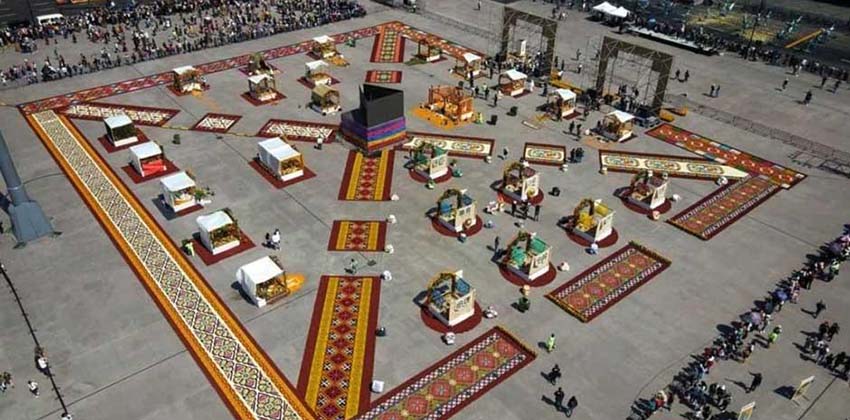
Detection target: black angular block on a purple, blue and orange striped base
<box><xmin>340</xmin><ymin>85</ymin><xmax>407</xmax><ymax>153</ymax></box>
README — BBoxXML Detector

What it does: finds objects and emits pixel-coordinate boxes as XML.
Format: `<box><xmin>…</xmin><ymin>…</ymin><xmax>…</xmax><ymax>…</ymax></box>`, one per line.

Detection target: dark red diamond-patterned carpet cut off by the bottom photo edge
<box><xmin>357</xmin><ymin>327</ymin><xmax>536</xmax><ymax>420</ymax></box>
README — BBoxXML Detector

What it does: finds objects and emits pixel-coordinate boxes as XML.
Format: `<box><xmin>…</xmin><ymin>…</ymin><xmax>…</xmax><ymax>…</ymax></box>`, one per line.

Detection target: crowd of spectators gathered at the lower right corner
<box><xmin>629</xmin><ymin>230</ymin><xmax>850</xmax><ymax>420</ymax></box>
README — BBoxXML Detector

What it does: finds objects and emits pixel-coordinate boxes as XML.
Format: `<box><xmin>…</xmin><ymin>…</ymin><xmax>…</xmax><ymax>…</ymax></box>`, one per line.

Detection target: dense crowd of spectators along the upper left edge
<box><xmin>0</xmin><ymin>0</ymin><xmax>366</xmax><ymax>86</ymax></box>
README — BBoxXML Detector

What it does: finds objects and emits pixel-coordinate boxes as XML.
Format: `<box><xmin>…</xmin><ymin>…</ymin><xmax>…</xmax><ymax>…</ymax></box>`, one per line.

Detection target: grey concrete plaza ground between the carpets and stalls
<box><xmin>0</xmin><ymin>0</ymin><xmax>850</xmax><ymax>420</ymax></box>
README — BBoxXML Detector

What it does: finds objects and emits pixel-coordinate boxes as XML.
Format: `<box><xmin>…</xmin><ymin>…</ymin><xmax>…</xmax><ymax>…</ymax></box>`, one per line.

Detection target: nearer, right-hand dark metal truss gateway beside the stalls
<box><xmin>594</xmin><ymin>36</ymin><xmax>673</xmax><ymax>116</ymax></box>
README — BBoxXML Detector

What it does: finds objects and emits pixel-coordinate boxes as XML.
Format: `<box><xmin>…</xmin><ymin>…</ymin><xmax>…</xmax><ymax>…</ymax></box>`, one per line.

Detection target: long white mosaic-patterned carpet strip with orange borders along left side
<box><xmin>27</xmin><ymin>111</ymin><xmax>312</xmax><ymax>420</ymax></box>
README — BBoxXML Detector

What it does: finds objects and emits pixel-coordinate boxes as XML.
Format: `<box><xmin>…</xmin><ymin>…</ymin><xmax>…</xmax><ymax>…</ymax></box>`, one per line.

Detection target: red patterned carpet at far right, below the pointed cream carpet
<box><xmin>667</xmin><ymin>176</ymin><xmax>779</xmax><ymax>241</ymax></box>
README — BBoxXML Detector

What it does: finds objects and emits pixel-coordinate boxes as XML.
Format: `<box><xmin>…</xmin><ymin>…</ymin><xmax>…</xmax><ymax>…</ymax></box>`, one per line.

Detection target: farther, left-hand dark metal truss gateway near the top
<box><xmin>499</xmin><ymin>7</ymin><xmax>558</xmax><ymax>75</ymax></box>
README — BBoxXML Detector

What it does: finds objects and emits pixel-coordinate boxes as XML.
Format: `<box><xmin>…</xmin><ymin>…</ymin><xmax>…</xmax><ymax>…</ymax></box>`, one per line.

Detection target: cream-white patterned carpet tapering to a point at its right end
<box><xmin>599</xmin><ymin>150</ymin><xmax>749</xmax><ymax>180</ymax></box>
